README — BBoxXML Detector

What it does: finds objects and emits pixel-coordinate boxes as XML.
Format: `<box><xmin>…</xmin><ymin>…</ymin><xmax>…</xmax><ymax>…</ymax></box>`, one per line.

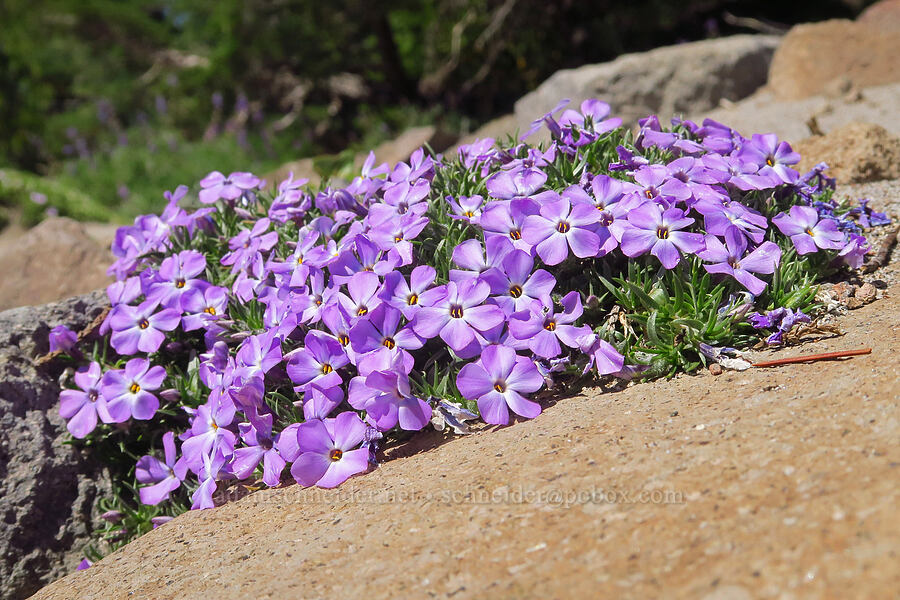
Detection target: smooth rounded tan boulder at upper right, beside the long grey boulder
<box><xmin>768</xmin><ymin>19</ymin><xmax>900</xmax><ymax>100</ymax></box>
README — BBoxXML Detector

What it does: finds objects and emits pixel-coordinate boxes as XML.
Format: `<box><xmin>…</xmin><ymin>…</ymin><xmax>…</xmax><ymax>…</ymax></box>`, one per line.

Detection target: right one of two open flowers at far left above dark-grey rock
<box><xmin>97</xmin><ymin>358</ymin><xmax>166</xmax><ymax>423</ymax></box>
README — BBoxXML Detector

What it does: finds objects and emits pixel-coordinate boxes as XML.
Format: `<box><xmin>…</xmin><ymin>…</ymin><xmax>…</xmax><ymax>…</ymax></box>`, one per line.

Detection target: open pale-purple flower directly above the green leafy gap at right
<box><xmin>622</xmin><ymin>202</ymin><xmax>706</xmax><ymax>269</ymax></box>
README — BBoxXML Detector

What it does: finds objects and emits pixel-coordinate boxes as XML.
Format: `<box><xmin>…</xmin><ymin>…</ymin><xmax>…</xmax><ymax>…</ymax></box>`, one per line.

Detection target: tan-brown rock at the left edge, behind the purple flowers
<box><xmin>0</xmin><ymin>217</ymin><xmax>113</xmax><ymax>310</ymax></box>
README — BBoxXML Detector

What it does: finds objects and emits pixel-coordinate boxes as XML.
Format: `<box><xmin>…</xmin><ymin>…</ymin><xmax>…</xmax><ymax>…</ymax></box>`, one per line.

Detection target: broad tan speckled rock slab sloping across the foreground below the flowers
<box><xmin>29</xmin><ymin>204</ymin><xmax>900</xmax><ymax>600</ymax></box>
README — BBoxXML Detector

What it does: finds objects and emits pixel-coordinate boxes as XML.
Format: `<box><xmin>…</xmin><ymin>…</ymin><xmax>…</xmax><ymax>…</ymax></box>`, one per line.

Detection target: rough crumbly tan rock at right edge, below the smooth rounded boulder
<box><xmin>794</xmin><ymin>122</ymin><xmax>900</xmax><ymax>183</ymax></box>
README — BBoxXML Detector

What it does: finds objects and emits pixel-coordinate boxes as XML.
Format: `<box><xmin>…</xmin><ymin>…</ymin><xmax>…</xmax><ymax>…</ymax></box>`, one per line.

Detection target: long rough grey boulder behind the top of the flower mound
<box><xmin>515</xmin><ymin>35</ymin><xmax>780</xmax><ymax>126</ymax></box>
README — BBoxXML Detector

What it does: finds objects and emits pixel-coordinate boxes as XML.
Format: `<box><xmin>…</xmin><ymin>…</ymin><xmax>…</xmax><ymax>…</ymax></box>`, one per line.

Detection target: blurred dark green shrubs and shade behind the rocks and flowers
<box><xmin>0</xmin><ymin>0</ymin><xmax>870</xmax><ymax>227</ymax></box>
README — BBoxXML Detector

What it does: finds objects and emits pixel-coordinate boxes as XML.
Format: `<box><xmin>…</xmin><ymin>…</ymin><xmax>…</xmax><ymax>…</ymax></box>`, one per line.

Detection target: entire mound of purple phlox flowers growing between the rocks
<box><xmin>55</xmin><ymin>95</ymin><xmax>866</xmax><ymax>524</ymax></box>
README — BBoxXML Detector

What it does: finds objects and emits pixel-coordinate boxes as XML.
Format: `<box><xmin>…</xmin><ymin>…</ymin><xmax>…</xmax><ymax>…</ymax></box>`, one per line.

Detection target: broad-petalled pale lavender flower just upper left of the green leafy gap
<box><xmin>522</xmin><ymin>198</ymin><xmax>600</xmax><ymax>265</ymax></box>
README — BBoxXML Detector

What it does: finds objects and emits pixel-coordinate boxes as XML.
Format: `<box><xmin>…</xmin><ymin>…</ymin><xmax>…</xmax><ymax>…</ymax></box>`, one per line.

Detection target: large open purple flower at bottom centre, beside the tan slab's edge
<box><xmin>456</xmin><ymin>345</ymin><xmax>544</xmax><ymax>425</ymax></box>
